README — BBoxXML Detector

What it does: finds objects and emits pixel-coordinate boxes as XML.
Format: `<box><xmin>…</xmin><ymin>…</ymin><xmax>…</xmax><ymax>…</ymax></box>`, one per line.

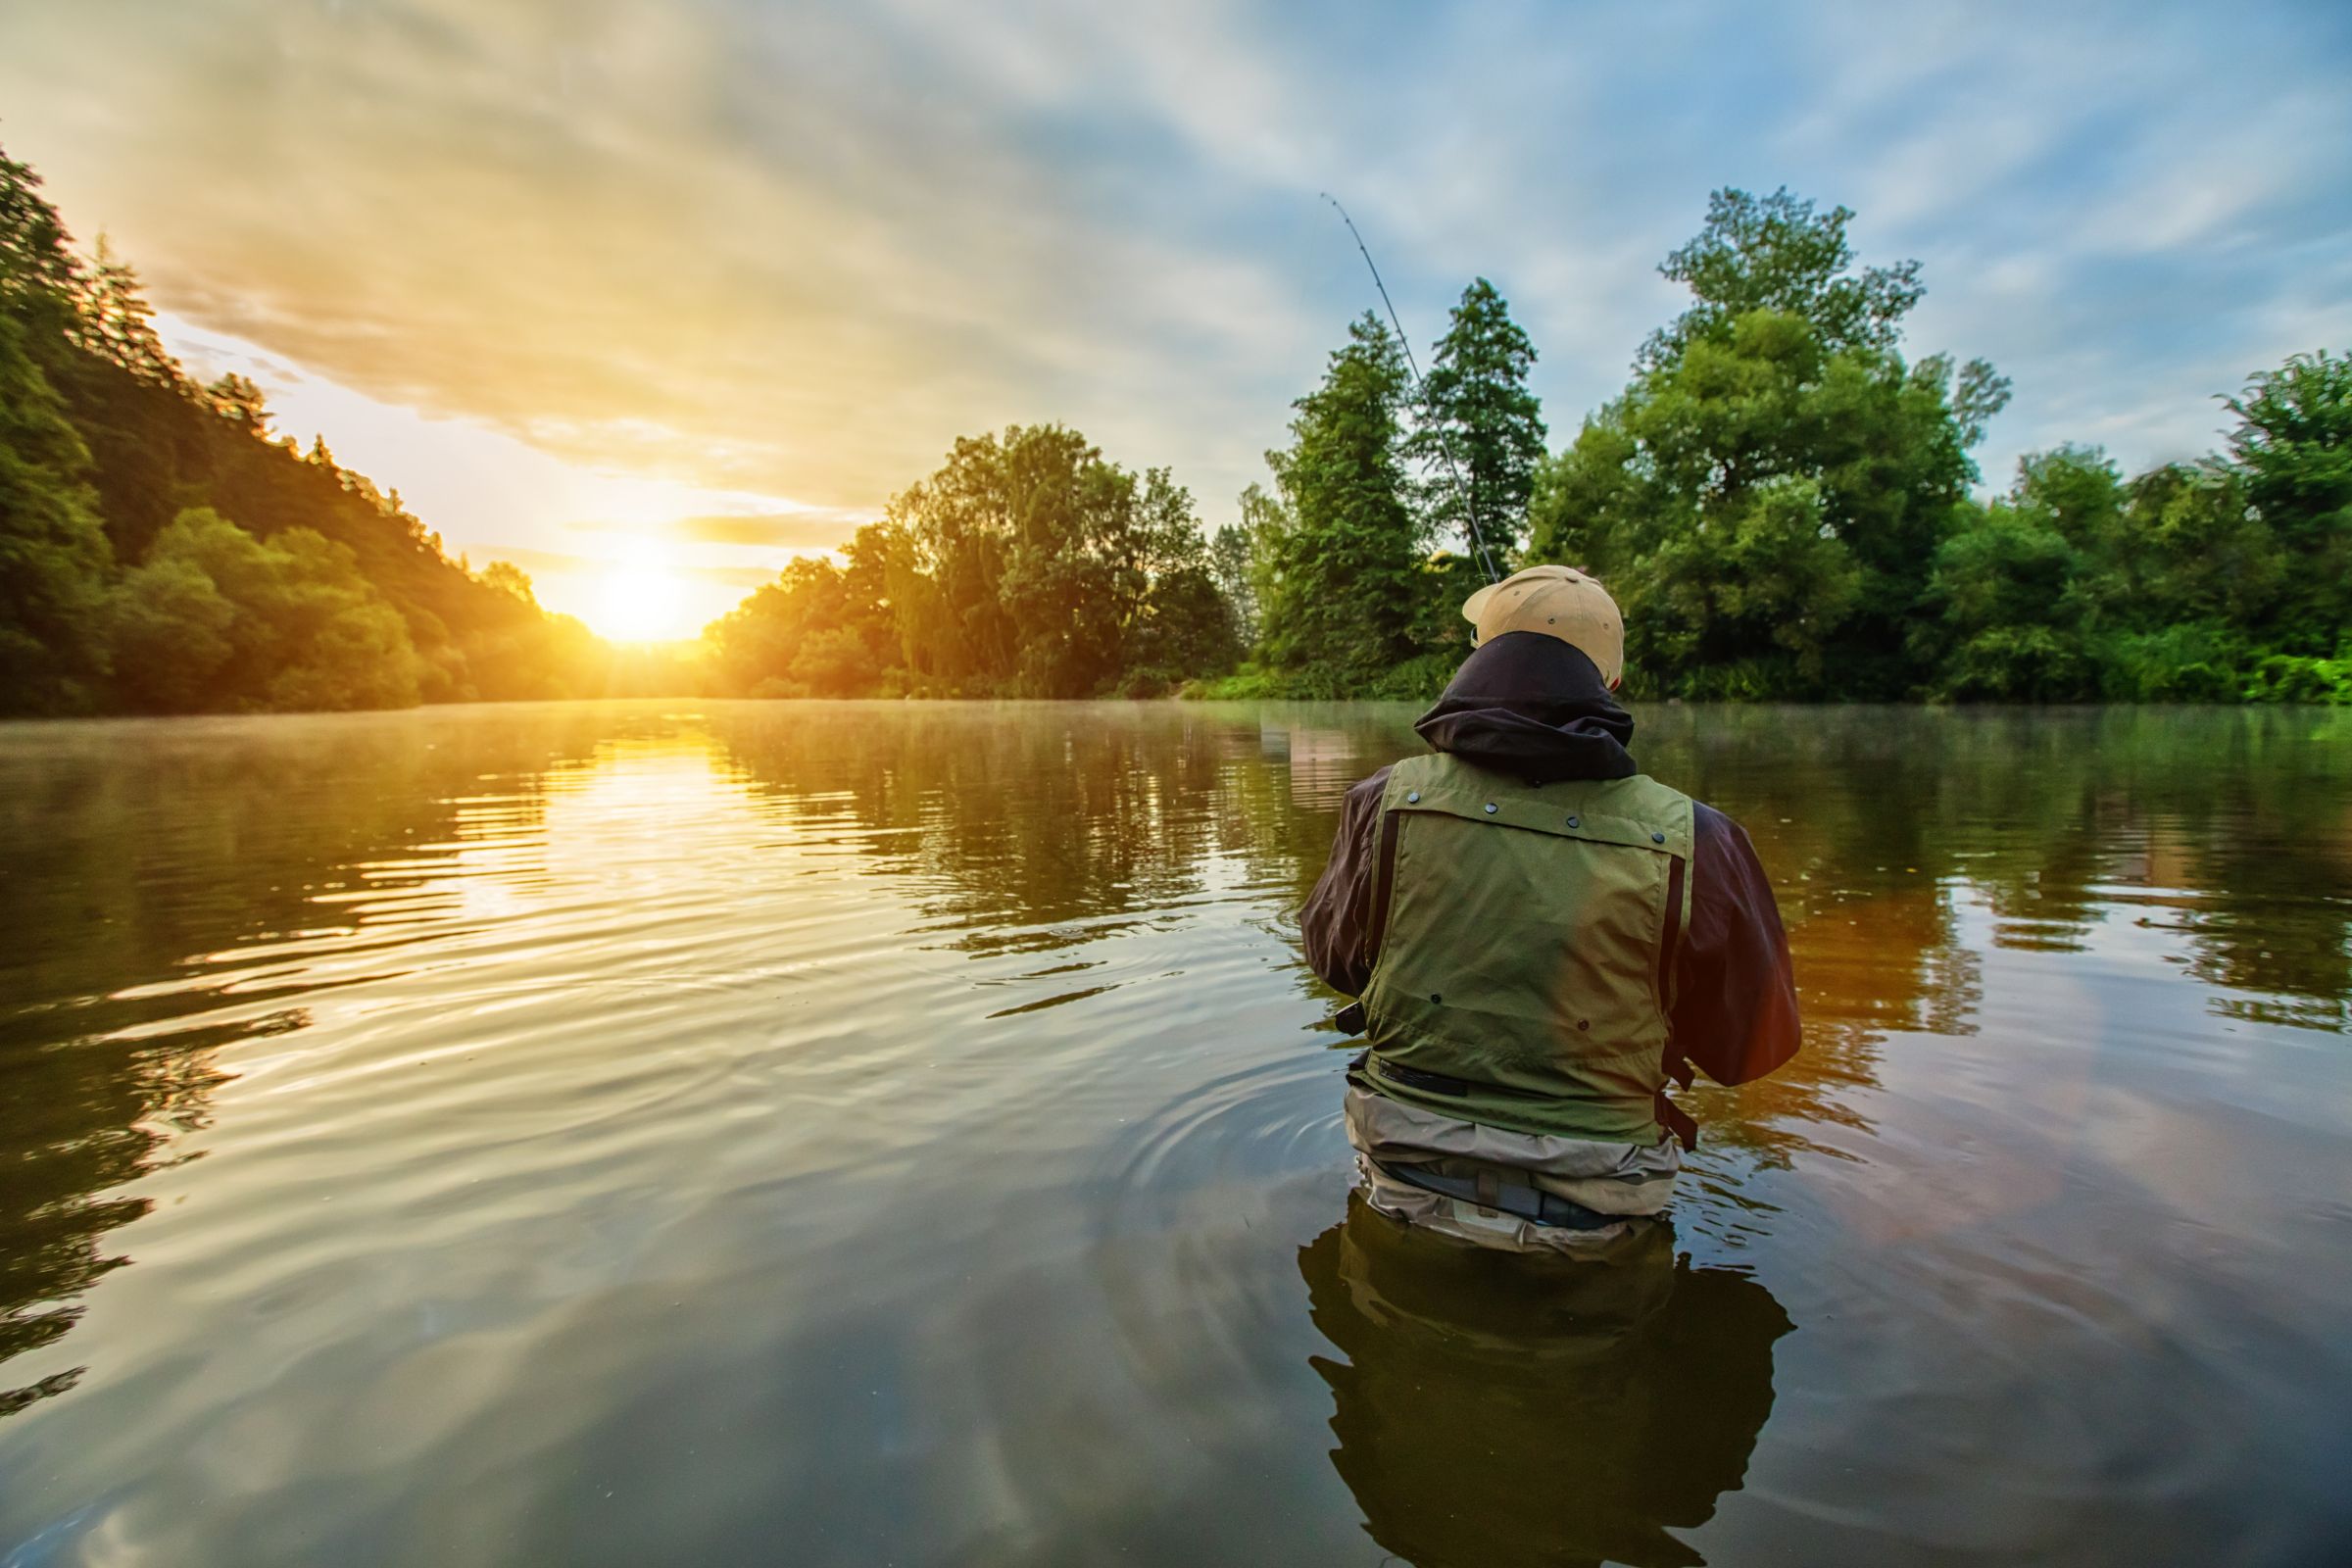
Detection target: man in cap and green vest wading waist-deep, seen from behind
<box><xmin>1298</xmin><ymin>566</ymin><xmax>1797</xmax><ymax>1250</ymax></box>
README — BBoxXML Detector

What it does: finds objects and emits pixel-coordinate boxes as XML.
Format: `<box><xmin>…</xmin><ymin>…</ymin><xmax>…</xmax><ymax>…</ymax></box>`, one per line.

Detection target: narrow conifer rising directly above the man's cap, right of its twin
<box><xmin>1406</xmin><ymin>277</ymin><xmax>1545</xmax><ymax>564</ymax></box>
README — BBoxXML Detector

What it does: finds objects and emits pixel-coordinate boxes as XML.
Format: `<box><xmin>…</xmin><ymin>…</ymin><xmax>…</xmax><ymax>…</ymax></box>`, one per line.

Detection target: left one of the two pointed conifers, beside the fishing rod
<box><xmin>1263</xmin><ymin>313</ymin><xmax>1423</xmax><ymax>694</ymax></box>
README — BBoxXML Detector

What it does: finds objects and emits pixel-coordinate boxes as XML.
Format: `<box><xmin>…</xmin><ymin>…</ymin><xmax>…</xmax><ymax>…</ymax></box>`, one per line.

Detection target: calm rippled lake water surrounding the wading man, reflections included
<box><xmin>0</xmin><ymin>703</ymin><xmax>2352</xmax><ymax>1568</ymax></box>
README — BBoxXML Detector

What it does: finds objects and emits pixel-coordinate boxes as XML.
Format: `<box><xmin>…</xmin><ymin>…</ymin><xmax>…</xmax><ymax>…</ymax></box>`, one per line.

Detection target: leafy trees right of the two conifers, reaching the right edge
<box><xmin>1529</xmin><ymin>190</ymin><xmax>2352</xmax><ymax>703</ymax></box>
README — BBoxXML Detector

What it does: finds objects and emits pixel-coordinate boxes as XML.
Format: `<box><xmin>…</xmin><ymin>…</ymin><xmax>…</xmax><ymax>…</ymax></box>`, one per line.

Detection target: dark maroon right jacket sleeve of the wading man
<box><xmin>1672</xmin><ymin>807</ymin><xmax>1797</xmax><ymax>1084</ymax></box>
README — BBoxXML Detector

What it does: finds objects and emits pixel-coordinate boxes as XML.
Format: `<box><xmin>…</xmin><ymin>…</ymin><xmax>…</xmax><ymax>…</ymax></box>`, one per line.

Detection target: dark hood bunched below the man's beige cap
<box><xmin>1413</xmin><ymin>632</ymin><xmax>1637</xmax><ymax>783</ymax></box>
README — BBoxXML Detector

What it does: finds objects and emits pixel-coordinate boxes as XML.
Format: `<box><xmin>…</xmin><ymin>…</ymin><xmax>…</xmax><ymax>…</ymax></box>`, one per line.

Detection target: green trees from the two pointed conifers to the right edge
<box><xmin>1213</xmin><ymin>190</ymin><xmax>2352</xmax><ymax>703</ymax></box>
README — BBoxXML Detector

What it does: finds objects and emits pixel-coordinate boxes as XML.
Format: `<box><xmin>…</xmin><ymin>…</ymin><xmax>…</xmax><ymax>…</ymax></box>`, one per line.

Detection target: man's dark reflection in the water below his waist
<box><xmin>1298</xmin><ymin>1192</ymin><xmax>1789</xmax><ymax>1568</ymax></box>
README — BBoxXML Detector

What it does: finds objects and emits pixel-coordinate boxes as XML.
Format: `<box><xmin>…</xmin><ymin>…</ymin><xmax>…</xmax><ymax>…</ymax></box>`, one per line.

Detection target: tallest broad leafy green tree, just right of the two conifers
<box><xmin>1529</xmin><ymin>190</ymin><xmax>2006</xmax><ymax>698</ymax></box>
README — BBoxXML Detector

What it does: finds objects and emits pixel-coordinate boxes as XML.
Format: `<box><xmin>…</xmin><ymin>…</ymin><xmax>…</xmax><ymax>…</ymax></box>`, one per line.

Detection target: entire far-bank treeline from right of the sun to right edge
<box><xmin>708</xmin><ymin>190</ymin><xmax>2352</xmax><ymax>701</ymax></box>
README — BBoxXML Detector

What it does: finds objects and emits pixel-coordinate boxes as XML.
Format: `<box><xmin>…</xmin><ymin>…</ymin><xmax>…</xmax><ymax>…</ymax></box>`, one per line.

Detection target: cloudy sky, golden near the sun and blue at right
<box><xmin>0</xmin><ymin>0</ymin><xmax>2352</xmax><ymax>637</ymax></box>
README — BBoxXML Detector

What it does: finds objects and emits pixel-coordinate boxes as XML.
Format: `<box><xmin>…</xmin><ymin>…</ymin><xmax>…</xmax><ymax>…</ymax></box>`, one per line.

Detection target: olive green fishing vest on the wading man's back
<box><xmin>1362</xmin><ymin>755</ymin><xmax>1691</xmax><ymax>1145</ymax></box>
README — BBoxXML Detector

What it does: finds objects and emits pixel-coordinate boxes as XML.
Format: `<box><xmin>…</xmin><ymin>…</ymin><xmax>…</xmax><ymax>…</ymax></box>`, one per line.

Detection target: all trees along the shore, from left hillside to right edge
<box><xmin>0</xmin><ymin>155</ymin><xmax>2352</xmax><ymax>714</ymax></box>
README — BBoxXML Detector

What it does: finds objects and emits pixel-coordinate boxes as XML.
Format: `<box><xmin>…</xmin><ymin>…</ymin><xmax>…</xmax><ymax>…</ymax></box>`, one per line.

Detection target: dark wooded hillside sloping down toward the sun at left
<box><xmin>0</xmin><ymin>140</ymin><xmax>610</xmax><ymax>714</ymax></box>
